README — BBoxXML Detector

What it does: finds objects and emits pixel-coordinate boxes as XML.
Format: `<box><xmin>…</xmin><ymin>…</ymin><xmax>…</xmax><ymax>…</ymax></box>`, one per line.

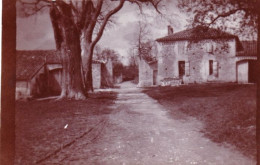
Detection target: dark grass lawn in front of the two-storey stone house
<box><xmin>144</xmin><ymin>84</ymin><xmax>256</xmax><ymax>158</ymax></box>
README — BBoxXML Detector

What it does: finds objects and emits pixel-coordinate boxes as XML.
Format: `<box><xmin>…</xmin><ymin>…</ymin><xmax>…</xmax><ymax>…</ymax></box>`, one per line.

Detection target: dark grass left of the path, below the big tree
<box><xmin>15</xmin><ymin>92</ymin><xmax>116</xmax><ymax>164</ymax></box>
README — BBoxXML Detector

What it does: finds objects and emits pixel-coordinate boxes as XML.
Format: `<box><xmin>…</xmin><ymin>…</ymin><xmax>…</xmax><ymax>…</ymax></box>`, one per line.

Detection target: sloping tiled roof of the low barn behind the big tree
<box><xmin>16</xmin><ymin>50</ymin><xmax>60</xmax><ymax>80</ymax></box>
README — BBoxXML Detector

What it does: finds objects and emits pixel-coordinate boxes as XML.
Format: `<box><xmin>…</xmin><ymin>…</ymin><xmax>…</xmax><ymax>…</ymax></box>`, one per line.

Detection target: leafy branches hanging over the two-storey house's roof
<box><xmin>178</xmin><ymin>0</ymin><xmax>258</xmax><ymax>38</ymax></box>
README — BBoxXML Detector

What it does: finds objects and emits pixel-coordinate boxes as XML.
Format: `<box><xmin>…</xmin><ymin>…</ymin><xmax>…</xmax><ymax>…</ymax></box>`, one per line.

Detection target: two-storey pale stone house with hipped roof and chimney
<box><xmin>138</xmin><ymin>26</ymin><xmax>256</xmax><ymax>86</ymax></box>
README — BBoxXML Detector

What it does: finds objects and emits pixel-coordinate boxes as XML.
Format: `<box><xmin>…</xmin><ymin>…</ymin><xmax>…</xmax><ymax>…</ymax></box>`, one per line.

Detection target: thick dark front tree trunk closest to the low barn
<box><xmin>50</xmin><ymin>3</ymin><xmax>87</xmax><ymax>100</ymax></box>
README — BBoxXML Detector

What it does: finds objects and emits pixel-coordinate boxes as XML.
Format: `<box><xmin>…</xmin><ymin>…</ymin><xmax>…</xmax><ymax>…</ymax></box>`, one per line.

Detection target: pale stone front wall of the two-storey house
<box><xmin>158</xmin><ymin>39</ymin><xmax>236</xmax><ymax>83</ymax></box>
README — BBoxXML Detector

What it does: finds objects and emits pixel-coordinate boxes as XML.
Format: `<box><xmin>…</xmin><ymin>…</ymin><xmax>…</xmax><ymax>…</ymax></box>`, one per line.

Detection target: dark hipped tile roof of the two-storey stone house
<box><xmin>156</xmin><ymin>26</ymin><xmax>236</xmax><ymax>42</ymax></box>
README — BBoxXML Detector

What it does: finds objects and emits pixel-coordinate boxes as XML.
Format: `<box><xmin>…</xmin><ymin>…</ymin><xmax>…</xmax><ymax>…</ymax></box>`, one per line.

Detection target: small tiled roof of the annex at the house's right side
<box><xmin>238</xmin><ymin>41</ymin><xmax>257</xmax><ymax>56</ymax></box>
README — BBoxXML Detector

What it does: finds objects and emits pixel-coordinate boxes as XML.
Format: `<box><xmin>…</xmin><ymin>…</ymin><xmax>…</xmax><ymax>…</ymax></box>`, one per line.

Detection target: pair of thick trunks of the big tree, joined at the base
<box><xmin>50</xmin><ymin>0</ymin><xmax>125</xmax><ymax>99</ymax></box>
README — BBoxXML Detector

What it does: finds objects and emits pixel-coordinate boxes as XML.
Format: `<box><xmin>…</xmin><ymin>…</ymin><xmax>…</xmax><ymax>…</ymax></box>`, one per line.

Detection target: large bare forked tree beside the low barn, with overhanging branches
<box><xmin>18</xmin><ymin>0</ymin><xmax>161</xmax><ymax>99</ymax></box>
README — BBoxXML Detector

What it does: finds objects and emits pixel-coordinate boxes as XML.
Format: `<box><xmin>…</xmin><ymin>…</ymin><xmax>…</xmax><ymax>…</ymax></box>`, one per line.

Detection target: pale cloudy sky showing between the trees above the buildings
<box><xmin>17</xmin><ymin>1</ymin><xmax>187</xmax><ymax>64</ymax></box>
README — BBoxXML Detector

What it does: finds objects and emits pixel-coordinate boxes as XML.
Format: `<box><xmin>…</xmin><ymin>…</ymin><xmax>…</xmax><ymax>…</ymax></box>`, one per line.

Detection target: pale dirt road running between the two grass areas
<box><xmin>42</xmin><ymin>83</ymin><xmax>256</xmax><ymax>165</ymax></box>
